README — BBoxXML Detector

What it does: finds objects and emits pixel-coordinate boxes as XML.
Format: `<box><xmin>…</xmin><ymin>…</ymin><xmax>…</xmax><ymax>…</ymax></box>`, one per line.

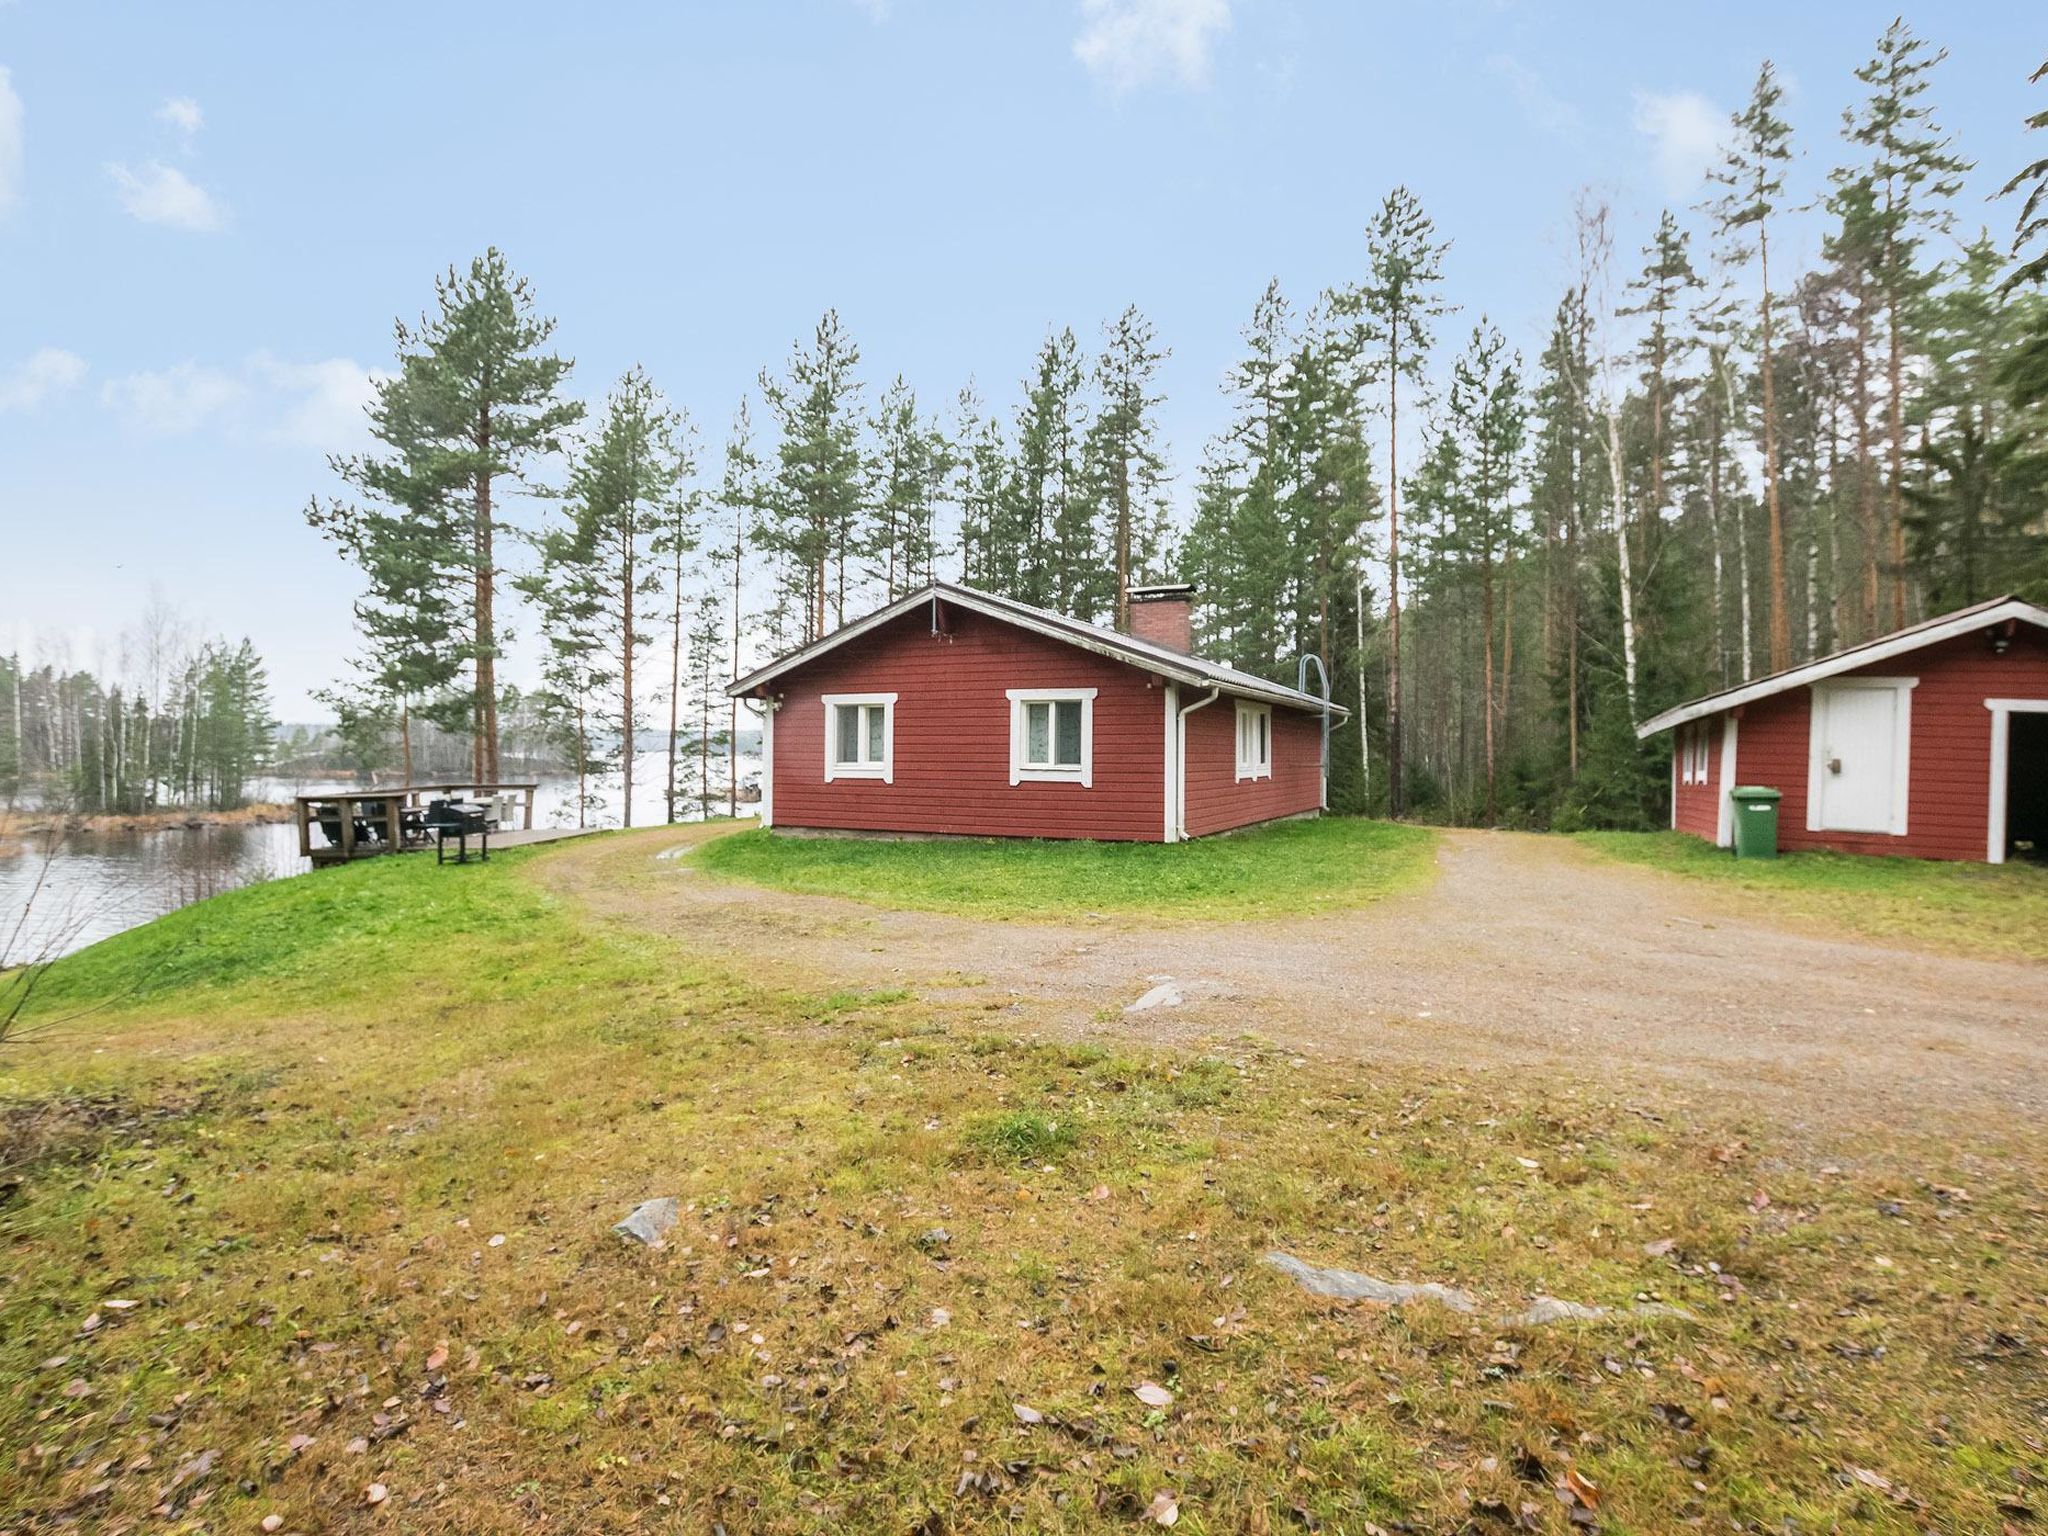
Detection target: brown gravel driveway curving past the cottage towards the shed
<box><xmin>537</xmin><ymin>831</ymin><xmax>2048</xmax><ymax>1130</ymax></box>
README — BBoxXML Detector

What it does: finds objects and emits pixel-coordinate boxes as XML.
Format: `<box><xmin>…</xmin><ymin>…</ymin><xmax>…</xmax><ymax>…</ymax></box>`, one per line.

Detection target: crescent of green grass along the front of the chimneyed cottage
<box><xmin>692</xmin><ymin>817</ymin><xmax>1436</xmax><ymax>920</ymax></box>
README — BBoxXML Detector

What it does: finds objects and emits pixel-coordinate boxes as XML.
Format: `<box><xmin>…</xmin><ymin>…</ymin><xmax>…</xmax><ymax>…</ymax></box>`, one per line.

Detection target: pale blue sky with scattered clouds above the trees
<box><xmin>0</xmin><ymin>0</ymin><xmax>2048</xmax><ymax>719</ymax></box>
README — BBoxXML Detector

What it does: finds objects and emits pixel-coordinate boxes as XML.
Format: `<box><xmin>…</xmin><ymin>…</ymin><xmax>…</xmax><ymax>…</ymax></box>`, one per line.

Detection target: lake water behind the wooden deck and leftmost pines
<box><xmin>0</xmin><ymin>752</ymin><xmax>760</xmax><ymax>965</ymax></box>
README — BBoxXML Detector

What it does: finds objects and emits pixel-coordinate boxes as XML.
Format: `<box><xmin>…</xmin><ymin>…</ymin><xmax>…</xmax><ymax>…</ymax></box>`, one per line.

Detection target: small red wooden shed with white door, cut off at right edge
<box><xmin>1636</xmin><ymin>598</ymin><xmax>2048</xmax><ymax>864</ymax></box>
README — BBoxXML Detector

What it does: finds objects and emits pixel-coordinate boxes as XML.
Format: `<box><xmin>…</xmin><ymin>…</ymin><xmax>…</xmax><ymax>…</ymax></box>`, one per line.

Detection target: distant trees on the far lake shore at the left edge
<box><xmin>0</xmin><ymin>626</ymin><xmax>276</xmax><ymax>815</ymax></box>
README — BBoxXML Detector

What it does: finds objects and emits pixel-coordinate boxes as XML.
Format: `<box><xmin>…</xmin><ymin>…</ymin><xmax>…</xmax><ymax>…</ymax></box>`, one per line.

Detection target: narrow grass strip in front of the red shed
<box><xmin>1577</xmin><ymin>831</ymin><xmax>2048</xmax><ymax>961</ymax></box>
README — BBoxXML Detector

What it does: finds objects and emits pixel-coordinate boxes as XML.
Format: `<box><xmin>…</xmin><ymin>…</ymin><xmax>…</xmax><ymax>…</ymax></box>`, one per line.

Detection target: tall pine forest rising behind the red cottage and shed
<box><xmin>309</xmin><ymin>23</ymin><xmax>2048</xmax><ymax>825</ymax></box>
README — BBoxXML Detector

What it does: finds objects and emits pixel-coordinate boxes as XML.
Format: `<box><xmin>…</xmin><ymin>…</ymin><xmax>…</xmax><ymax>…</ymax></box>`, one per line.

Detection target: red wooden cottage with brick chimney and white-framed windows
<box><xmin>727</xmin><ymin>582</ymin><xmax>1346</xmax><ymax>842</ymax></box>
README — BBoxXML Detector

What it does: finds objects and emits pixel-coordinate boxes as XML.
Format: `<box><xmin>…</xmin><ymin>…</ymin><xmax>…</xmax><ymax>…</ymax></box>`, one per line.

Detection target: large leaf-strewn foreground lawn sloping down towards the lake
<box><xmin>0</xmin><ymin>840</ymin><xmax>2048</xmax><ymax>1534</ymax></box>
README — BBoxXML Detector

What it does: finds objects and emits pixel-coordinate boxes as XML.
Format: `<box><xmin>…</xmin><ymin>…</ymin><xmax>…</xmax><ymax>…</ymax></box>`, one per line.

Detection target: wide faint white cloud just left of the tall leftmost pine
<box><xmin>100</xmin><ymin>352</ymin><xmax>385</xmax><ymax>453</ymax></box>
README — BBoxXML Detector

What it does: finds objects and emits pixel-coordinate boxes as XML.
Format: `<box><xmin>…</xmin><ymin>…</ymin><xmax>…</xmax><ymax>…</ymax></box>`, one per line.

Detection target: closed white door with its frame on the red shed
<box><xmin>1806</xmin><ymin>678</ymin><xmax>1919</xmax><ymax>838</ymax></box>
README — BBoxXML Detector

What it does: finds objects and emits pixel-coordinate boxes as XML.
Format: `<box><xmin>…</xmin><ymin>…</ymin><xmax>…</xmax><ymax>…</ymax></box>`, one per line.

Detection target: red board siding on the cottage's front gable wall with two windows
<box><xmin>774</xmin><ymin>608</ymin><xmax>1165</xmax><ymax>842</ymax></box>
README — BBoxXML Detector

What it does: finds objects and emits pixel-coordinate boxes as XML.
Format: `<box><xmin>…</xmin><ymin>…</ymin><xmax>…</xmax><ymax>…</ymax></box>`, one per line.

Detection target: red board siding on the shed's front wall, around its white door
<box><xmin>1735</xmin><ymin>625</ymin><xmax>2048</xmax><ymax>860</ymax></box>
